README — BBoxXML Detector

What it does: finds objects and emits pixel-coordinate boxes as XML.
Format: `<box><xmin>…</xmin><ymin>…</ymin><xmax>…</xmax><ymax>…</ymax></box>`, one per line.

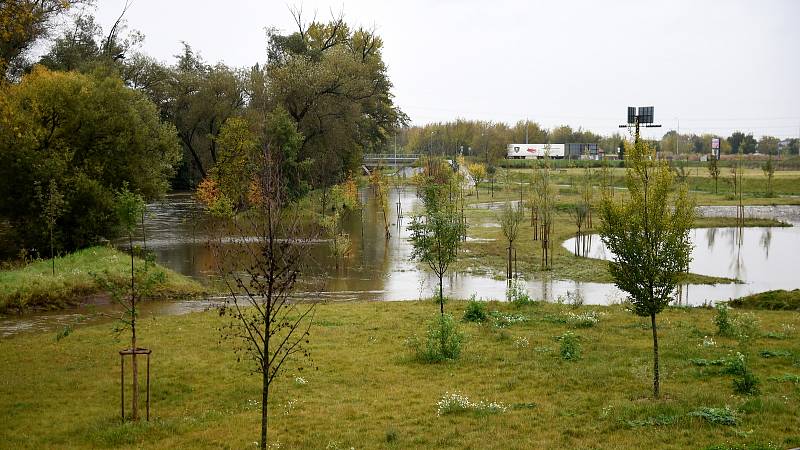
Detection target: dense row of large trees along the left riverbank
<box><xmin>0</xmin><ymin>0</ymin><xmax>400</xmax><ymax>251</ymax></box>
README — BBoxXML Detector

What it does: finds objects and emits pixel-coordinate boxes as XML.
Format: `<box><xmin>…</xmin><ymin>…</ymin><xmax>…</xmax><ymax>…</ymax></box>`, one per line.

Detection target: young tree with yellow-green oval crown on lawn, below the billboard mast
<box><xmin>600</xmin><ymin>139</ymin><xmax>694</xmax><ymax>398</ymax></box>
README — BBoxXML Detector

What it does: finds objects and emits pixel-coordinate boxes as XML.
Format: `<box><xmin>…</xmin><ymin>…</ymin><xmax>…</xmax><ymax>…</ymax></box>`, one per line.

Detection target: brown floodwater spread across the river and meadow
<box><xmin>0</xmin><ymin>191</ymin><xmax>800</xmax><ymax>336</ymax></box>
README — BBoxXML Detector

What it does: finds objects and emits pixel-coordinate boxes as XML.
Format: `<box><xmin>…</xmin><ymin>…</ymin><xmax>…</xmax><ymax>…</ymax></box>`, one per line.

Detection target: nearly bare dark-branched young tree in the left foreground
<box><xmin>213</xmin><ymin>114</ymin><xmax>315</xmax><ymax>449</ymax></box>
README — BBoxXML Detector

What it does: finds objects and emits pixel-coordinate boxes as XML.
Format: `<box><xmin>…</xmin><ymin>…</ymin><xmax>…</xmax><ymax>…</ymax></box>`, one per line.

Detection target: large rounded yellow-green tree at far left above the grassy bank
<box><xmin>0</xmin><ymin>67</ymin><xmax>180</xmax><ymax>250</ymax></box>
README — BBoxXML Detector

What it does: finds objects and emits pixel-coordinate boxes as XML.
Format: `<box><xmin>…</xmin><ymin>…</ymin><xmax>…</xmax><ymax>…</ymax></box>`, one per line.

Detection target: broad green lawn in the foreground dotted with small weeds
<box><xmin>0</xmin><ymin>301</ymin><xmax>800</xmax><ymax>449</ymax></box>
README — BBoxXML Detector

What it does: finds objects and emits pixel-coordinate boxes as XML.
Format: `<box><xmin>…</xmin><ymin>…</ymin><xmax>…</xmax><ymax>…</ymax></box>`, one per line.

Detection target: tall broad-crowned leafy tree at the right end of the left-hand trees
<box><xmin>264</xmin><ymin>14</ymin><xmax>406</xmax><ymax>187</ymax></box>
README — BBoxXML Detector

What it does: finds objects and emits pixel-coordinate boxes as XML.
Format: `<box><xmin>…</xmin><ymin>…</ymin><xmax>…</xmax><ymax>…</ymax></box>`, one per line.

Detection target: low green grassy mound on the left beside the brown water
<box><xmin>0</xmin><ymin>247</ymin><xmax>204</xmax><ymax>313</ymax></box>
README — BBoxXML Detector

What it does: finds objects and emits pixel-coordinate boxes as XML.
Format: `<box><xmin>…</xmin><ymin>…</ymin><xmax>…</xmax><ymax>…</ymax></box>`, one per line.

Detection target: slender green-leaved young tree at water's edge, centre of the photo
<box><xmin>408</xmin><ymin>184</ymin><xmax>466</xmax><ymax>316</ymax></box>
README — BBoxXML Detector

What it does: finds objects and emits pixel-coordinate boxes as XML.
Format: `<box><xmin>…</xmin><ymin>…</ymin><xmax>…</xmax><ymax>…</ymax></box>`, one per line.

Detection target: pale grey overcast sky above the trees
<box><xmin>89</xmin><ymin>0</ymin><xmax>800</xmax><ymax>137</ymax></box>
